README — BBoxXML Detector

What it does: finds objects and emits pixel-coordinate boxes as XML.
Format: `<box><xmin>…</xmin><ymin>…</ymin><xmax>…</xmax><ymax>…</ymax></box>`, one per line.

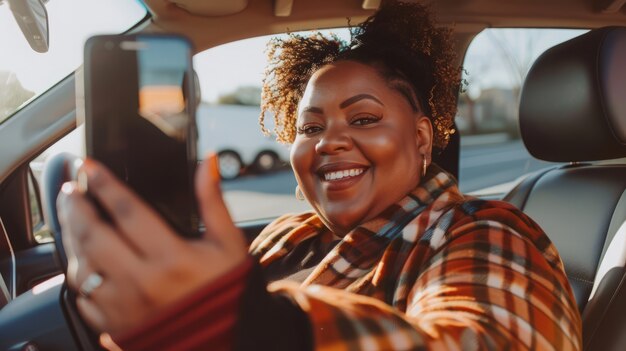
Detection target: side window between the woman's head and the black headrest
<box><xmin>456</xmin><ymin>28</ymin><xmax>586</xmax><ymax>195</ymax></box>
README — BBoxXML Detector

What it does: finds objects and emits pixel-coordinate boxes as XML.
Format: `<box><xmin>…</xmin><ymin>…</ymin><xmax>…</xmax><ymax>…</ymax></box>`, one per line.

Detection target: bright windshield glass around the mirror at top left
<box><xmin>0</xmin><ymin>0</ymin><xmax>146</xmax><ymax>123</ymax></box>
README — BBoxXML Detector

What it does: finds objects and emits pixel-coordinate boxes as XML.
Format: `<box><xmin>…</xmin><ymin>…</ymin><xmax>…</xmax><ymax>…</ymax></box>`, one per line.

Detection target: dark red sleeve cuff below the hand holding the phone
<box><xmin>113</xmin><ymin>258</ymin><xmax>253</xmax><ymax>351</ymax></box>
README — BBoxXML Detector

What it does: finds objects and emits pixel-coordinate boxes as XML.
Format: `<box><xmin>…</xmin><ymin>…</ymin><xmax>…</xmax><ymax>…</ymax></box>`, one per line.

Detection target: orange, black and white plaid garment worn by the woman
<box><xmin>250</xmin><ymin>166</ymin><xmax>582</xmax><ymax>350</ymax></box>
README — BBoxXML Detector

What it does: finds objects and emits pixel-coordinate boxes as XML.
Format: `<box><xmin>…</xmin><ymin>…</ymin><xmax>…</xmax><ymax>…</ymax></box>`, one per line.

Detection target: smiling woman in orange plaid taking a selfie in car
<box><xmin>59</xmin><ymin>2</ymin><xmax>581</xmax><ymax>350</ymax></box>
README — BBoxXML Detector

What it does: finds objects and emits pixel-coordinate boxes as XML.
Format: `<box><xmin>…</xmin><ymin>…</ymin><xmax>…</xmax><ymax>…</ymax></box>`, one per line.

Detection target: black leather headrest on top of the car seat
<box><xmin>520</xmin><ymin>27</ymin><xmax>626</xmax><ymax>162</ymax></box>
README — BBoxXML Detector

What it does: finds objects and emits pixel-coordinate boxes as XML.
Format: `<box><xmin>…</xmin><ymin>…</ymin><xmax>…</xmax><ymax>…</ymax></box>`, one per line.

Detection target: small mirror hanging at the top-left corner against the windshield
<box><xmin>8</xmin><ymin>0</ymin><xmax>49</xmax><ymax>53</ymax></box>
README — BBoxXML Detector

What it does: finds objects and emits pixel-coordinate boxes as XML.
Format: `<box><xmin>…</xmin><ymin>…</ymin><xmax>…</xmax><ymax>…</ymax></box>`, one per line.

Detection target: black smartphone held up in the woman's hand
<box><xmin>84</xmin><ymin>34</ymin><xmax>200</xmax><ymax>238</ymax></box>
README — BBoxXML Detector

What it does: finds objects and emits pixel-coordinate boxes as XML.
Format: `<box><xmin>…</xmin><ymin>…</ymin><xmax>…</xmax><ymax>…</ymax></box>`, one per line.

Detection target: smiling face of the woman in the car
<box><xmin>291</xmin><ymin>61</ymin><xmax>432</xmax><ymax>235</ymax></box>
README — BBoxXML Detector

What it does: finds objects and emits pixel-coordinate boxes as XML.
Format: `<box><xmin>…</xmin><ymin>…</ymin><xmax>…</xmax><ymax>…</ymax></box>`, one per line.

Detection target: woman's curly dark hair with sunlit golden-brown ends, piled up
<box><xmin>260</xmin><ymin>1</ymin><xmax>461</xmax><ymax>150</ymax></box>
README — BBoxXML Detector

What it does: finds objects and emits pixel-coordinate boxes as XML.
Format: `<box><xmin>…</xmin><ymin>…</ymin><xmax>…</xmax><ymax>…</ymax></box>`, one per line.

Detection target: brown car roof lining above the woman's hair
<box><xmin>144</xmin><ymin>0</ymin><xmax>626</xmax><ymax>53</ymax></box>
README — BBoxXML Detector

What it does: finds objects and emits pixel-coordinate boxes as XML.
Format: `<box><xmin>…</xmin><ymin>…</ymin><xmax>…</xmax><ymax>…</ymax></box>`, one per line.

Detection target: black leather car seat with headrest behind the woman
<box><xmin>504</xmin><ymin>27</ymin><xmax>626</xmax><ymax>350</ymax></box>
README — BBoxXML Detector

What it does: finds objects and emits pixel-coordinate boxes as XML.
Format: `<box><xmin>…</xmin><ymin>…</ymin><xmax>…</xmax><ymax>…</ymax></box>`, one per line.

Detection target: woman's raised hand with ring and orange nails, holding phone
<box><xmin>57</xmin><ymin>155</ymin><xmax>246</xmax><ymax>334</ymax></box>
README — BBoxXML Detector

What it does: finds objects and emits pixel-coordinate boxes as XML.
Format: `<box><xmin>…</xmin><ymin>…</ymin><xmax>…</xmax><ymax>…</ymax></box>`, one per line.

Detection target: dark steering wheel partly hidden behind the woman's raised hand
<box><xmin>41</xmin><ymin>153</ymin><xmax>102</xmax><ymax>351</ymax></box>
